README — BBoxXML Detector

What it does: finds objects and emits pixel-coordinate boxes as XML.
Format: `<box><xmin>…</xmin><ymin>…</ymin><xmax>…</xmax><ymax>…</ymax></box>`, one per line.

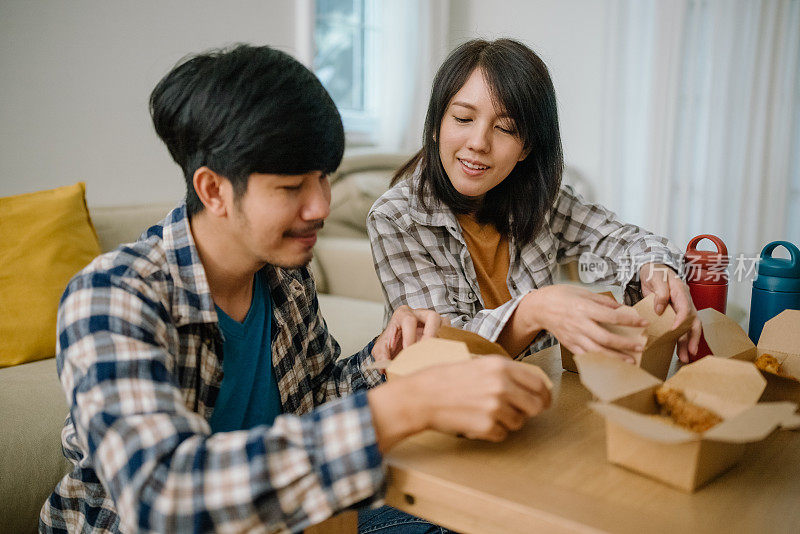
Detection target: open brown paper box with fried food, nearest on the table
<box><xmin>575</xmin><ymin>353</ymin><xmax>800</xmax><ymax>492</ymax></box>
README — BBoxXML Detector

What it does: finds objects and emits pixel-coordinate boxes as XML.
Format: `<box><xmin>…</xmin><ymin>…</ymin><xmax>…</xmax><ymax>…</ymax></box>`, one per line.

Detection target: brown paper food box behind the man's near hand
<box><xmin>385</xmin><ymin>326</ymin><xmax>553</xmax><ymax>389</ymax></box>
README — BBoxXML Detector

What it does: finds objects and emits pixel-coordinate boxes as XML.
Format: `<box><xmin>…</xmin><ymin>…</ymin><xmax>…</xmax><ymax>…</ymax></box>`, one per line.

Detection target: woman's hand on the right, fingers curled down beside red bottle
<box><xmin>639</xmin><ymin>263</ymin><xmax>703</xmax><ymax>363</ymax></box>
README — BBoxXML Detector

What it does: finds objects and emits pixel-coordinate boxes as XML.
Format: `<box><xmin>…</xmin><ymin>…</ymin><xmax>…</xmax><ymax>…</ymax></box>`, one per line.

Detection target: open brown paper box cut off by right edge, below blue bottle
<box><xmin>697</xmin><ymin>308</ymin><xmax>800</xmax><ymax>403</ymax></box>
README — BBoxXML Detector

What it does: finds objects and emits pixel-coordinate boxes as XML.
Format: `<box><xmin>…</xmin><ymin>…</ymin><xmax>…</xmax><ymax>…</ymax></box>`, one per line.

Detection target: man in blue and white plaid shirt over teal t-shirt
<box><xmin>40</xmin><ymin>45</ymin><xmax>549</xmax><ymax>532</ymax></box>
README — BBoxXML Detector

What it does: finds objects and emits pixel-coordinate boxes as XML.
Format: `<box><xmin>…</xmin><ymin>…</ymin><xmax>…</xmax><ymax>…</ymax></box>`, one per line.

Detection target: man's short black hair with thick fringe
<box><xmin>150</xmin><ymin>44</ymin><xmax>344</xmax><ymax>216</ymax></box>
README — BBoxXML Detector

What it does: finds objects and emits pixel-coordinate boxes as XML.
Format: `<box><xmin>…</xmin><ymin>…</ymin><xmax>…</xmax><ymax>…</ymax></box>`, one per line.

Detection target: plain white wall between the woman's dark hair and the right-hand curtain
<box><xmin>450</xmin><ymin>0</ymin><xmax>615</xmax><ymax>209</ymax></box>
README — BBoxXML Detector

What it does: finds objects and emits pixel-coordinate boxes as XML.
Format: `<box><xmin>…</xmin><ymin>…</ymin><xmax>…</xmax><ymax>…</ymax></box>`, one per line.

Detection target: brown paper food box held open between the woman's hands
<box><xmin>561</xmin><ymin>293</ymin><xmax>692</xmax><ymax>380</ymax></box>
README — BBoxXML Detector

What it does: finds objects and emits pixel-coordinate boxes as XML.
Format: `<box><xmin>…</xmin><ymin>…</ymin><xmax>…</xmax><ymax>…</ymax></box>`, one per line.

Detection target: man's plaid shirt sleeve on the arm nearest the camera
<box><xmin>58</xmin><ymin>273</ymin><xmax>384</xmax><ymax>532</ymax></box>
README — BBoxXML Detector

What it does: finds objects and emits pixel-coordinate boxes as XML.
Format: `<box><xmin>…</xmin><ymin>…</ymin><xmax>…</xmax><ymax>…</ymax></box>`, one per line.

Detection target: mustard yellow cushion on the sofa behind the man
<box><xmin>0</xmin><ymin>183</ymin><xmax>100</xmax><ymax>367</ymax></box>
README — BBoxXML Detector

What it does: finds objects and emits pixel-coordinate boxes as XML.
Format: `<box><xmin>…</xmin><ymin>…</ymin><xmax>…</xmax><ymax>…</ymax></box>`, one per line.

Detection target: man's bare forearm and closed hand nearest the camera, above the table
<box><xmin>367</xmin><ymin>356</ymin><xmax>550</xmax><ymax>452</ymax></box>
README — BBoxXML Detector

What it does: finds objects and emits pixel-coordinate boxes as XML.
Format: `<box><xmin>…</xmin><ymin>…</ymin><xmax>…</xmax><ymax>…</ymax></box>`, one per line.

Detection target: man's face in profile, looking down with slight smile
<box><xmin>232</xmin><ymin>171</ymin><xmax>331</xmax><ymax>268</ymax></box>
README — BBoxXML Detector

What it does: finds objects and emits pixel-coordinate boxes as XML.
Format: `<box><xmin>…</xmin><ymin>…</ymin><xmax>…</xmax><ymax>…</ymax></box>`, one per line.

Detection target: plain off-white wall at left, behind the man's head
<box><xmin>0</xmin><ymin>0</ymin><xmax>295</xmax><ymax>205</ymax></box>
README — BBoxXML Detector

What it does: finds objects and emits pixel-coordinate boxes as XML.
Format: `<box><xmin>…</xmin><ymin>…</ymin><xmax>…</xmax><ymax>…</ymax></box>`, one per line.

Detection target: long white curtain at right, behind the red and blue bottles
<box><xmin>603</xmin><ymin>0</ymin><xmax>800</xmax><ymax>308</ymax></box>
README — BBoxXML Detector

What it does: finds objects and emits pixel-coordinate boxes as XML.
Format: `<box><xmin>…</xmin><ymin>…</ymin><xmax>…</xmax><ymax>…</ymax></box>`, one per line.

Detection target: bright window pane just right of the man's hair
<box><xmin>313</xmin><ymin>0</ymin><xmax>379</xmax><ymax>144</ymax></box>
